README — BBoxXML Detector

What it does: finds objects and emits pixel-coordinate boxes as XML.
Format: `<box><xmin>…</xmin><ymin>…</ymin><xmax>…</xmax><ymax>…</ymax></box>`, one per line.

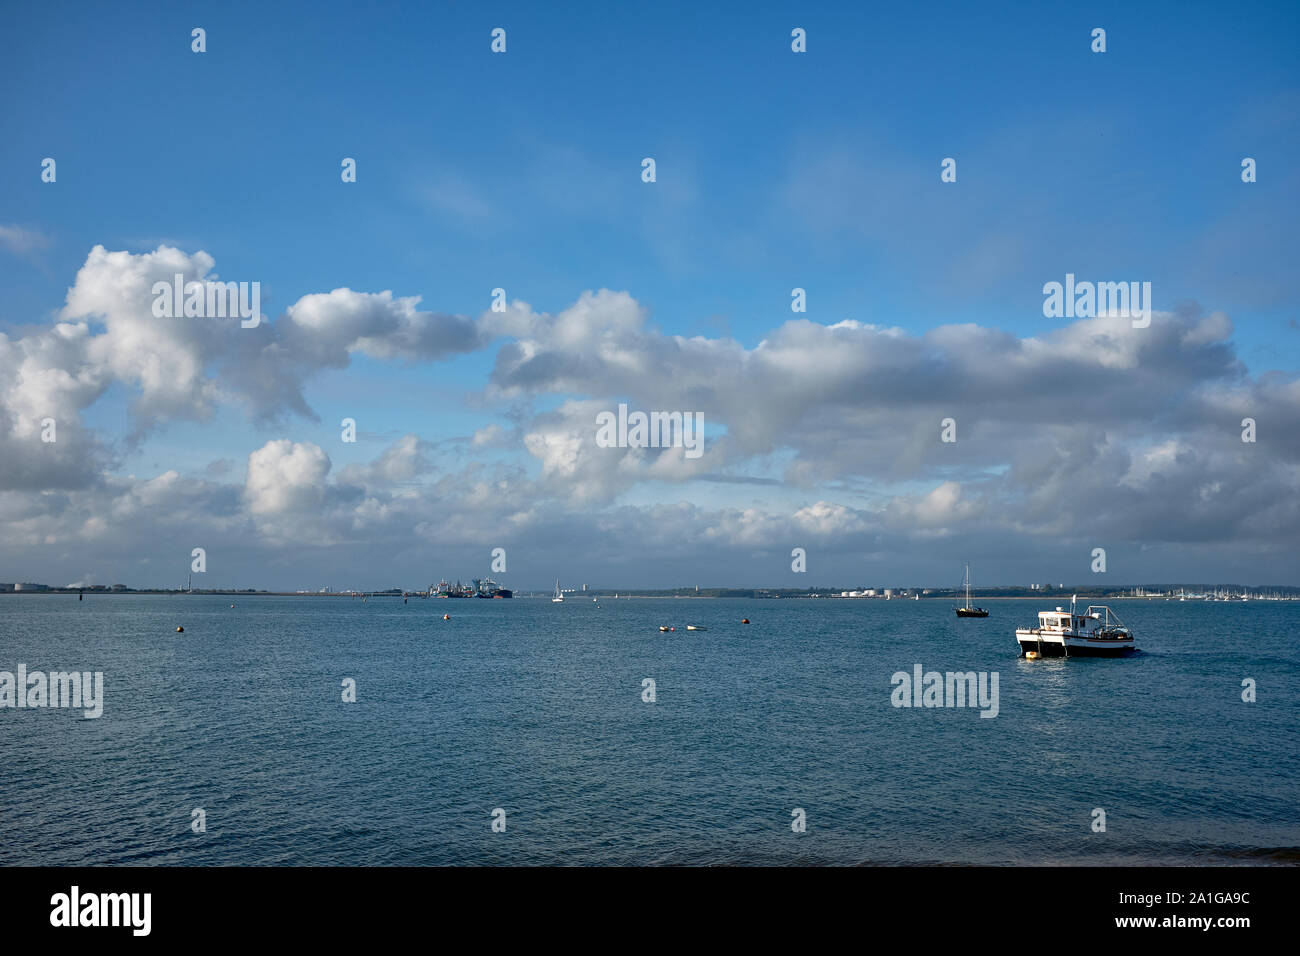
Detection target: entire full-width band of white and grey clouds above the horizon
<box><xmin>0</xmin><ymin>254</ymin><xmax>1300</xmax><ymax>584</ymax></box>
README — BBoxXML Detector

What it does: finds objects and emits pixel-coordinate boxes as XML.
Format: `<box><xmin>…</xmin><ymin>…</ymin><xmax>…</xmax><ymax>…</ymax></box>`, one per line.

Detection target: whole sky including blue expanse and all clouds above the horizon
<box><xmin>0</xmin><ymin>3</ymin><xmax>1300</xmax><ymax>589</ymax></box>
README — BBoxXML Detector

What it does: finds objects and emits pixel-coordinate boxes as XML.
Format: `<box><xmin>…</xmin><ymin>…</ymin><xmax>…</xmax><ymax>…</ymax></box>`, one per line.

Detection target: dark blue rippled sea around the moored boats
<box><xmin>0</xmin><ymin>593</ymin><xmax>1300</xmax><ymax>866</ymax></box>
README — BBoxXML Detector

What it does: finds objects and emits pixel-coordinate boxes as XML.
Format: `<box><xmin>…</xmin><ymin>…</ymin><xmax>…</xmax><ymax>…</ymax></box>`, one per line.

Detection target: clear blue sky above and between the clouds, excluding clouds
<box><xmin>0</xmin><ymin>3</ymin><xmax>1300</xmax><ymax>590</ymax></box>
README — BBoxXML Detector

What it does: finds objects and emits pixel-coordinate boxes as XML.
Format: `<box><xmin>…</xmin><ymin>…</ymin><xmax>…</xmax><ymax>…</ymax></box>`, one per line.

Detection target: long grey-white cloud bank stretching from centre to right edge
<box><xmin>490</xmin><ymin>290</ymin><xmax>1300</xmax><ymax>561</ymax></box>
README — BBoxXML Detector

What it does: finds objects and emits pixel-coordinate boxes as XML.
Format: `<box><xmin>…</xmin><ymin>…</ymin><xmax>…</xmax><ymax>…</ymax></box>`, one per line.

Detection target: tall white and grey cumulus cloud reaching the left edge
<box><xmin>0</xmin><ymin>243</ymin><xmax>485</xmax><ymax>488</ymax></box>
